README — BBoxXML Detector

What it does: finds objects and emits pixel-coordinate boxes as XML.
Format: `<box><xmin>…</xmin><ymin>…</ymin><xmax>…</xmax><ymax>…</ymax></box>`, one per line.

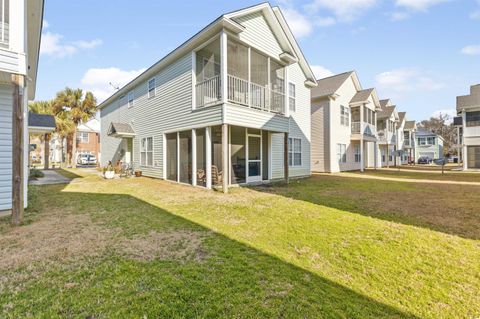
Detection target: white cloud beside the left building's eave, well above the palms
<box><xmin>40</xmin><ymin>31</ymin><xmax>102</xmax><ymax>58</ymax></box>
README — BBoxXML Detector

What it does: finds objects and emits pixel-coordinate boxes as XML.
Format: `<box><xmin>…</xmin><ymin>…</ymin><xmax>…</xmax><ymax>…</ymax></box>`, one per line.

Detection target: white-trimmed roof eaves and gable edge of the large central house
<box><xmin>98</xmin><ymin>2</ymin><xmax>316</xmax><ymax>109</ymax></box>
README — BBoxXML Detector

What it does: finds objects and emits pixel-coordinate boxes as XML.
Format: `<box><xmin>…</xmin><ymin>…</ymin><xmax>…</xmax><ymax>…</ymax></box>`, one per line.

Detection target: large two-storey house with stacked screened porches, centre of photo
<box><xmin>99</xmin><ymin>3</ymin><xmax>316</xmax><ymax>191</ymax></box>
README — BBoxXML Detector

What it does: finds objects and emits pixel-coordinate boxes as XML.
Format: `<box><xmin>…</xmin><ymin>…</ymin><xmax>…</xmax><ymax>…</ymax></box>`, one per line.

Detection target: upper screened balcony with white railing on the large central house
<box><xmin>195</xmin><ymin>38</ymin><xmax>287</xmax><ymax>115</ymax></box>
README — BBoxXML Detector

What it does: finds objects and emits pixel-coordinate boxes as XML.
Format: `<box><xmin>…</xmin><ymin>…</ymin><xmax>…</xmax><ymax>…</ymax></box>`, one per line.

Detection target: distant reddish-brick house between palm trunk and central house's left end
<box><xmin>75</xmin><ymin>118</ymin><xmax>100</xmax><ymax>160</ymax></box>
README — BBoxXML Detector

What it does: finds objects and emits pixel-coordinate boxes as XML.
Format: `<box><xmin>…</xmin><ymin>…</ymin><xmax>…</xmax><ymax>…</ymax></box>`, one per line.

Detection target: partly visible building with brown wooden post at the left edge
<box><xmin>0</xmin><ymin>0</ymin><xmax>43</xmax><ymax>220</ymax></box>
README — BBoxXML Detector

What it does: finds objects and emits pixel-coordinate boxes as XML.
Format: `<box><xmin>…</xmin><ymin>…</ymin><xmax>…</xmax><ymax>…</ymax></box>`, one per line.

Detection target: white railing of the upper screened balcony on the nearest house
<box><xmin>195</xmin><ymin>74</ymin><xmax>285</xmax><ymax>114</ymax></box>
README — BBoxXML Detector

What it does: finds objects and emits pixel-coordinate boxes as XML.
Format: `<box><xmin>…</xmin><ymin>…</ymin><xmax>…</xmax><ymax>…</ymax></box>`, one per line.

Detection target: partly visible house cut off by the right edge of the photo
<box><xmin>457</xmin><ymin>84</ymin><xmax>480</xmax><ymax>169</ymax></box>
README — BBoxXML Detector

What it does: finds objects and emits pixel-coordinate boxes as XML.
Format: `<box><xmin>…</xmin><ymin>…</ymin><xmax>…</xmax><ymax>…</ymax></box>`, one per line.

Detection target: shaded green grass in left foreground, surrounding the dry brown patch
<box><xmin>0</xmin><ymin>185</ymin><xmax>415</xmax><ymax>318</ymax></box>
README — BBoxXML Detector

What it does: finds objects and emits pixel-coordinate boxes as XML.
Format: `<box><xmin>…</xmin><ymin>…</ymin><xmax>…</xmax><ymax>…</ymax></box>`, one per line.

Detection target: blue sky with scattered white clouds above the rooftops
<box><xmin>37</xmin><ymin>0</ymin><xmax>480</xmax><ymax>121</ymax></box>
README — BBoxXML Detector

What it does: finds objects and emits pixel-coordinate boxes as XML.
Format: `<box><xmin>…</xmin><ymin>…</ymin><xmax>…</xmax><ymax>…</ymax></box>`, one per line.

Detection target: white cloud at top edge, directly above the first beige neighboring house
<box><xmin>307</xmin><ymin>0</ymin><xmax>379</xmax><ymax>22</ymax></box>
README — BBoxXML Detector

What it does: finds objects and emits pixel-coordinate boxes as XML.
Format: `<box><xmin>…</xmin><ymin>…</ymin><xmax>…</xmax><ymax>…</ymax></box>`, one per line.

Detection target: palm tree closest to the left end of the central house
<box><xmin>53</xmin><ymin>87</ymin><xmax>97</xmax><ymax>167</ymax></box>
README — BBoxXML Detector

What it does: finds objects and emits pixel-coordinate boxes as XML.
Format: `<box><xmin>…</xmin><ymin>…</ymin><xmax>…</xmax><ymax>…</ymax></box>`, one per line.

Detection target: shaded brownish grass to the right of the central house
<box><xmin>252</xmin><ymin>173</ymin><xmax>480</xmax><ymax>240</ymax></box>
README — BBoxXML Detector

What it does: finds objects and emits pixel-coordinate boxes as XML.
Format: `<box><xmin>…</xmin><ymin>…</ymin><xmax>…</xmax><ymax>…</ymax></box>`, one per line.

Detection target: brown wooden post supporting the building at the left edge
<box><xmin>12</xmin><ymin>74</ymin><xmax>25</xmax><ymax>226</ymax></box>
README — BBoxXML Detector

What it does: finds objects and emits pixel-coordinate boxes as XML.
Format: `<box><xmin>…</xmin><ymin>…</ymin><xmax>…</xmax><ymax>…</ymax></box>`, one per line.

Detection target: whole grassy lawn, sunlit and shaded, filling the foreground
<box><xmin>0</xmin><ymin>170</ymin><xmax>480</xmax><ymax>318</ymax></box>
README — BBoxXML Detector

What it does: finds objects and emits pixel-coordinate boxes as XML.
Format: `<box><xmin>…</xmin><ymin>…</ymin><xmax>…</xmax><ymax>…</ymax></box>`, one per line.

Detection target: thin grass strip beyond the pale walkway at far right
<box><xmin>357</xmin><ymin>169</ymin><xmax>480</xmax><ymax>183</ymax></box>
